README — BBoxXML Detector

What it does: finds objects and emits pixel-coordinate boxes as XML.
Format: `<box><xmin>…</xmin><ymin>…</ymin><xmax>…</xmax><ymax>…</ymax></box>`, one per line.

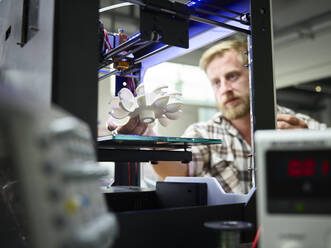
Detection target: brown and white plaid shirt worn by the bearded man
<box><xmin>183</xmin><ymin>106</ymin><xmax>326</xmax><ymax>194</ymax></box>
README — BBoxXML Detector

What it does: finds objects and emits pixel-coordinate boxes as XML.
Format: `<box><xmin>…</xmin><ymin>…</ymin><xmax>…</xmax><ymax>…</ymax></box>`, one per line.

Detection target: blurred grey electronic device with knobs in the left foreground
<box><xmin>0</xmin><ymin>87</ymin><xmax>117</xmax><ymax>248</ymax></box>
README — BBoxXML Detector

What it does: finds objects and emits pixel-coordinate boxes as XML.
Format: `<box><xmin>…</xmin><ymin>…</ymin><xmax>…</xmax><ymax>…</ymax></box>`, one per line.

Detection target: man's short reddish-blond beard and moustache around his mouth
<box><xmin>219</xmin><ymin>94</ymin><xmax>250</xmax><ymax>121</ymax></box>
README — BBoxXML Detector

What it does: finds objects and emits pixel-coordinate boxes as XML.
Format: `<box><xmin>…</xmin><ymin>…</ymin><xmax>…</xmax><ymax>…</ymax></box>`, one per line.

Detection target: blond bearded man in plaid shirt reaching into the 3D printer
<box><xmin>109</xmin><ymin>40</ymin><xmax>325</xmax><ymax>193</ymax></box>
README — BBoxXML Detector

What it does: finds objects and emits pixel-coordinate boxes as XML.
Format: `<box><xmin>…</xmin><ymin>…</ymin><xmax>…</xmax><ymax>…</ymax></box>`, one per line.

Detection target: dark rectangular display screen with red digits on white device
<box><xmin>266</xmin><ymin>150</ymin><xmax>331</xmax><ymax>213</ymax></box>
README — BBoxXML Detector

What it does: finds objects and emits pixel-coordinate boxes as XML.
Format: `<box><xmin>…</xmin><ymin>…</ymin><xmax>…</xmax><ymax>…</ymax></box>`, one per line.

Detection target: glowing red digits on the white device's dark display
<box><xmin>287</xmin><ymin>158</ymin><xmax>330</xmax><ymax>177</ymax></box>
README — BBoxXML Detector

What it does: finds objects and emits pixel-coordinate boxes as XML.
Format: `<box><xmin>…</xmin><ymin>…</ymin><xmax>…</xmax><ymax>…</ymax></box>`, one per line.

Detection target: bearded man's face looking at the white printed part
<box><xmin>206</xmin><ymin>50</ymin><xmax>250</xmax><ymax>120</ymax></box>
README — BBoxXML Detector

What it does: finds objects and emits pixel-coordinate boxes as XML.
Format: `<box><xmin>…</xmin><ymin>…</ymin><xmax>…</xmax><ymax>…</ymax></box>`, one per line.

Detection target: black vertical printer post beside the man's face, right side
<box><xmin>248</xmin><ymin>0</ymin><xmax>276</xmax><ymax>184</ymax></box>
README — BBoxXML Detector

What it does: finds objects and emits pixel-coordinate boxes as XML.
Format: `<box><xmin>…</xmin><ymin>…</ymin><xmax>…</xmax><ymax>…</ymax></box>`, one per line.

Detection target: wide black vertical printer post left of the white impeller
<box><xmin>52</xmin><ymin>0</ymin><xmax>99</xmax><ymax>140</ymax></box>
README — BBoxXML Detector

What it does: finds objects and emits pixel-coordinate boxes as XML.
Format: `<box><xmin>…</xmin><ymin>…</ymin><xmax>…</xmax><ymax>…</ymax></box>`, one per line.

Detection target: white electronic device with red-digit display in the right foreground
<box><xmin>255</xmin><ymin>129</ymin><xmax>331</xmax><ymax>248</ymax></box>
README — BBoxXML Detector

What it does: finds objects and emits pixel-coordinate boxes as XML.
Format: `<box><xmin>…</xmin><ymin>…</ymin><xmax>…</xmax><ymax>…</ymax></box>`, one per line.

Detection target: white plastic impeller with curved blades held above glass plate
<box><xmin>109</xmin><ymin>84</ymin><xmax>183</xmax><ymax>127</ymax></box>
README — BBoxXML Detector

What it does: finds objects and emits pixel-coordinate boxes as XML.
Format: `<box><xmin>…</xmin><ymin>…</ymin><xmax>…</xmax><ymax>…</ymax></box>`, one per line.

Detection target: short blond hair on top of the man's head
<box><xmin>199</xmin><ymin>40</ymin><xmax>248</xmax><ymax>71</ymax></box>
